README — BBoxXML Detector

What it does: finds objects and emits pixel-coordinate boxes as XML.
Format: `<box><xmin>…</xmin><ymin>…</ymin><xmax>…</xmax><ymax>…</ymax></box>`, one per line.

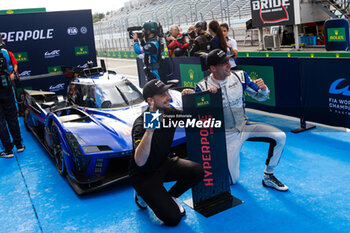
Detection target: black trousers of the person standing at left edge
<box><xmin>0</xmin><ymin>86</ymin><xmax>22</xmax><ymax>151</ymax></box>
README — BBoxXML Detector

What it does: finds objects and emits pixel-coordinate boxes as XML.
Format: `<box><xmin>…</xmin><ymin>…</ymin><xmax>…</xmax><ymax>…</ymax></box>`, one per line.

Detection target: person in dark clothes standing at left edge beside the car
<box><xmin>0</xmin><ymin>41</ymin><xmax>25</xmax><ymax>158</ymax></box>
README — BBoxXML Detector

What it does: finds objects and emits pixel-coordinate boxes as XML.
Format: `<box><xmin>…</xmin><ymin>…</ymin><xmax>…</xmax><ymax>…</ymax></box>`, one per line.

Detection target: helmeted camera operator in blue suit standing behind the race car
<box><xmin>132</xmin><ymin>21</ymin><xmax>161</xmax><ymax>80</ymax></box>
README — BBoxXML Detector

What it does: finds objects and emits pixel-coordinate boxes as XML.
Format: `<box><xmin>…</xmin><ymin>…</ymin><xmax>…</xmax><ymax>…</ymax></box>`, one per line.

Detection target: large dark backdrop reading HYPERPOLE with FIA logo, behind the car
<box><xmin>0</xmin><ymin>10</ymin><xmax>97</xmax><ymax>92</ymax></box>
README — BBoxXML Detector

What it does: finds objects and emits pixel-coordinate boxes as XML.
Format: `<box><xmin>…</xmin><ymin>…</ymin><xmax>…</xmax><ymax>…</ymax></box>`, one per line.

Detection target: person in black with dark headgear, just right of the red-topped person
<box><xmin>190</xmin><ymin>21</ymin><xmax>212</xmax><ymax>56</ymax></box>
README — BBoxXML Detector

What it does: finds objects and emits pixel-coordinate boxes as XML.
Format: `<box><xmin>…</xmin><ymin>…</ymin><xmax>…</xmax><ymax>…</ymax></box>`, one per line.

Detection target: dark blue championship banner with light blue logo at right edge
<box><xmin>300</xmin><ymin>58</ymin><xmax>350</xmax><ymax>128</ymax></box>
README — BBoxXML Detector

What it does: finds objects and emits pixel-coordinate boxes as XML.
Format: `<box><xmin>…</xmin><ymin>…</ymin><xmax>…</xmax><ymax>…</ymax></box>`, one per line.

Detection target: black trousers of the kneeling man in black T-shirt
<box><xmin>131</xmin><ymin>157</ymin><xmax>204</xmax><ymax>226</ymax></box>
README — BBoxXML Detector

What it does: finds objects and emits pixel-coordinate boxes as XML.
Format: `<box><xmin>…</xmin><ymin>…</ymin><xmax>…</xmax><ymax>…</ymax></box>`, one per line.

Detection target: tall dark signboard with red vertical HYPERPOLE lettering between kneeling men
<box><xmin>182</xmin><ymin>89</ymin><xmax>242</xmax><ymax>217</ymax></box>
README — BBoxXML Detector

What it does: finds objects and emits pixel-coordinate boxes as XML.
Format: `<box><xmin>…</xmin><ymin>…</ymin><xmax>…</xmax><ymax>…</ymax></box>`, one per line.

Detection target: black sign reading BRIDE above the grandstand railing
<box><xmin>250</xmin><ymin>0</ymin><xmax>295</xmax><ymax>28</ymax></box>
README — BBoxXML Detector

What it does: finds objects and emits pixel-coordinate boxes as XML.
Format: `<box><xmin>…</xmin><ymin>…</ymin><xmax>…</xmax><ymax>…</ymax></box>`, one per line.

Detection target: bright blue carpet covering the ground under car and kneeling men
<box><xmin>0</xmin><ymin>113</ymin><xmax>350</xmax><ymax>233</ymax></box>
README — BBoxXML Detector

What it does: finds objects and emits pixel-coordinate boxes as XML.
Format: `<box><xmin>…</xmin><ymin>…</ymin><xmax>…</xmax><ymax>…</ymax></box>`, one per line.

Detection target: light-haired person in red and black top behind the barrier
<box><xmin>166</xmin><ymin>25</ymin><xmax>189</xmax><ymax>57</ymax></box>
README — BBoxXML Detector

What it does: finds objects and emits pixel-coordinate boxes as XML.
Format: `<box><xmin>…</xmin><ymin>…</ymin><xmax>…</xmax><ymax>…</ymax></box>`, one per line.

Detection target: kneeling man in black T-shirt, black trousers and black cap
<box><xmin>129</xmin><ymin>80</ymin><xmax>204</xmax><ymax>226</ymax></box>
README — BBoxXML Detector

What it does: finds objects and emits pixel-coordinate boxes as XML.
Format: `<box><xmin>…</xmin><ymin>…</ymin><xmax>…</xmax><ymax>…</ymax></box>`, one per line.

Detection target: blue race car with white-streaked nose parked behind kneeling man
<box><xmin>24</xmin><ymin>64</ymin><xmax>185</xmax><ymax>195</ymax></box>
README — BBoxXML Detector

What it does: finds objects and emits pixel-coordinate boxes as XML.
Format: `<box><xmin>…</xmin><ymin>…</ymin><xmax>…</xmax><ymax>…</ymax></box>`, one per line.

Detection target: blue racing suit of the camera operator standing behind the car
<box><xmin>134</xmin><ymin>38</ymin><xmax>160</xmax><ymax>80</ymax></box>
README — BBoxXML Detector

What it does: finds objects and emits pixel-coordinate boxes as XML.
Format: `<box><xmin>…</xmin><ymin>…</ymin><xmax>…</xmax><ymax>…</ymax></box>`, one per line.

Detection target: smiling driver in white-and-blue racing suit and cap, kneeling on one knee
<box><xmin>195</xmin><ymin>49</ymin><xmax>288</xmax><ymax>191</ymax></box>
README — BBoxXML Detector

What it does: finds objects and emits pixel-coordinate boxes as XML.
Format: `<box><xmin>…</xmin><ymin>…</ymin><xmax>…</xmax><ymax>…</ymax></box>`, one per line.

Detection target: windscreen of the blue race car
<box><xmin>68</xmin><ymin>80</ymin><xmax>143</xmax><ymax>108</ymax></box>
